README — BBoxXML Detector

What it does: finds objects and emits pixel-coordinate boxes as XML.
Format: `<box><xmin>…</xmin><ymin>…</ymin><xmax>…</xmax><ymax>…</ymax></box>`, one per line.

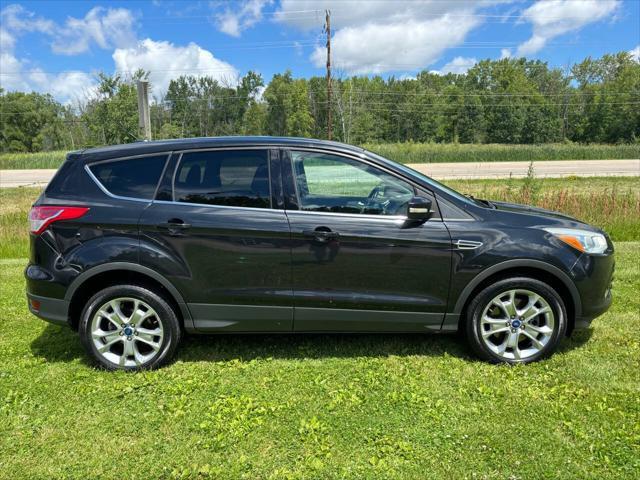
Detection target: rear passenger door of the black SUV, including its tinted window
<box><xmin>140</xmin><ymin>148</ymin><xmax>293</xmax><ymax>332</ymax></box>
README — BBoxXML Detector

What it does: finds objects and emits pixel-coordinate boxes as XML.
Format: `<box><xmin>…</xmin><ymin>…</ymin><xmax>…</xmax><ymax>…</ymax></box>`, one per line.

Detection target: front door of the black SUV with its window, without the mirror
<box><xmin>282</xmin><ymin>149</ymin><xmax>451</xmax><ymax>331</ymax></box>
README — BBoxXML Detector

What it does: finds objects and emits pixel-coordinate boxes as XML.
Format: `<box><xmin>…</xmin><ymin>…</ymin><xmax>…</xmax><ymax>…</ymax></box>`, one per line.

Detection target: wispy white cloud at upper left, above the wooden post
<box><xmin>51</xmin><ymin>7</ymin><xmax>136</xmax><ymax>55</ymax></box>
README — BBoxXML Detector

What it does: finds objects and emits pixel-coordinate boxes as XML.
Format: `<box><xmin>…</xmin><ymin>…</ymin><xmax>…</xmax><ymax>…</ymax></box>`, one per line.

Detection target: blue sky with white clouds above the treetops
<box><xmin>0</xmin><ymin>0</ymin><xmax>640</xmax><ymax>103</ymax></box>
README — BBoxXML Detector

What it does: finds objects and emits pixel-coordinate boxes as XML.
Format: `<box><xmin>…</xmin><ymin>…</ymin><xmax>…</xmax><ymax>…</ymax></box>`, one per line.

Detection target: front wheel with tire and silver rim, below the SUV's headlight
<box><xmin>464</xmin><ymin>277</ymin><xmax>567</xmax><ymax>364</ymax></box>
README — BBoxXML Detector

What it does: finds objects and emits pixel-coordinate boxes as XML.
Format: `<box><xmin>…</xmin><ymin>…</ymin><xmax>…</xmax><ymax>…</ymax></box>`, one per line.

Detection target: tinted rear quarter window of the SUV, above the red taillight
<box><xmin>89</xmin><ymin>155</ymin><xmax>167</xmax><ymax>200</ymax></box>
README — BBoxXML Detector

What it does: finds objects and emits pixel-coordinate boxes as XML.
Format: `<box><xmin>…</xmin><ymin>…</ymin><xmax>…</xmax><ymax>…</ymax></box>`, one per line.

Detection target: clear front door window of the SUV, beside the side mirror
<box><xmin>291</xmin><ymin>151</ymin><xmax>414</xmax><ymax>215</ymax></box>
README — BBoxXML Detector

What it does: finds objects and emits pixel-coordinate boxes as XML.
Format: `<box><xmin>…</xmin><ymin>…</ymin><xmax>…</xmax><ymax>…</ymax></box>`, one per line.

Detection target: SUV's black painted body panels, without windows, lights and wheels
<box><xmin>26</xmin><ymin>137</ymin><xmax>614</xmax><ymax>332</ymax></box>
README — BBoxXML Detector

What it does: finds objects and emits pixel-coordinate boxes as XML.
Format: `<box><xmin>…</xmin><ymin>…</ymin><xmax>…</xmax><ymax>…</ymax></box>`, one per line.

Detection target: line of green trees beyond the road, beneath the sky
<box><xmin>0</xmin><ymin>52</ymin><xmax>640</xmax><ymax>152</ymax></box>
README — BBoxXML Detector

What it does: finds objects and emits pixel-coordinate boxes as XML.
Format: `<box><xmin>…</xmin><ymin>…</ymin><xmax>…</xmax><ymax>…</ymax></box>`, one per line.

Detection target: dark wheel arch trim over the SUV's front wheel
<box><xmin>453</xmin><ymin>259</ymin><xmax>582</xmax><ymax>335</ymax></box>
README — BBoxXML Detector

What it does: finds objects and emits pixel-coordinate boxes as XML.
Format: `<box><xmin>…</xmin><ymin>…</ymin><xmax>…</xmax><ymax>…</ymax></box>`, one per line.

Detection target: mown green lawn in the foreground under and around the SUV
<box><xmin>0</xmin><ymin>242</ymin><xmax>640</xmax><ymax>480</ymax></box>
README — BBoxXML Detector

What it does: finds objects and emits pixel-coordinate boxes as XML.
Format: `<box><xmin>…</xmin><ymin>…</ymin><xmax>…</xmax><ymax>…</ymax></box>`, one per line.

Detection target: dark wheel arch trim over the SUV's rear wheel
<box><xmin>64</xmin><ymin>262</ymin><xmax>192</xmax><ymax>329</ymax></box>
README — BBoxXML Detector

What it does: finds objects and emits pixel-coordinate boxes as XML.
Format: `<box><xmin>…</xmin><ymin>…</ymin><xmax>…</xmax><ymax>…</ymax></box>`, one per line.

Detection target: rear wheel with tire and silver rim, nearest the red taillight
<box><xmin>79</xmin><ymin>285</ymin><xmax>181</xmax><ymax>371</ymax></box>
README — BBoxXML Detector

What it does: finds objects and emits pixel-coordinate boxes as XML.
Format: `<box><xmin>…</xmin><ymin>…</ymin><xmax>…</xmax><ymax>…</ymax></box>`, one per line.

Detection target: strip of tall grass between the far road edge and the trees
<box><xmin>0</xmin><ymin>143</ymin><xmax>640</xmax><ymax>170</ymax></box>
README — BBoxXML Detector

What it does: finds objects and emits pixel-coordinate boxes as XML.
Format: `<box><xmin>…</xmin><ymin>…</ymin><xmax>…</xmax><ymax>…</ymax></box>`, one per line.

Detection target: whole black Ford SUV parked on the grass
<box><xmin>25</xmin><ymin>137</ymin><xmax>614</xmax><ymax>370</ymax></box>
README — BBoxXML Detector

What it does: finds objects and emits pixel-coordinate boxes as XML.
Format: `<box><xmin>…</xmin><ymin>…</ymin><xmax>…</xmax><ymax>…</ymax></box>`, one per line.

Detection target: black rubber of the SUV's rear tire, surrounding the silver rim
<box><xmin>79</xmin><ymin>285</ymin><xmax>181</xmax><ymax>371</ymax></box>
